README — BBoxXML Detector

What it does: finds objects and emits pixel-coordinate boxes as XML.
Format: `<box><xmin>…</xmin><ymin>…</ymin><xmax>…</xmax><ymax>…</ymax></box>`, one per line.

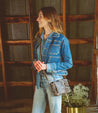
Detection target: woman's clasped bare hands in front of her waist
<box><xmin>33</xmin><ymin>60</ymin><xmax>47</xmax><ymax>72</ymax></box>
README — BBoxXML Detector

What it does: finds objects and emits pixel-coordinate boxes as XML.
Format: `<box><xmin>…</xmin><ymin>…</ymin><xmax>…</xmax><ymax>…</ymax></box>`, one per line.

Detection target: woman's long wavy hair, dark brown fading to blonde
<box><xmin>39</xmin><ymin>7</ymin><xmax>63</xmax><ymax>34</ymax></box>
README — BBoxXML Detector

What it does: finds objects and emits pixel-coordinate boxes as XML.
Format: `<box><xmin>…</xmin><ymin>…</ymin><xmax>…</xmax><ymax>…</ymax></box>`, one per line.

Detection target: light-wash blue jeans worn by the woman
<box><xmin>32</xmin><ymin>86</ymin><xmax>62</xmax><ymax>113</ymax></box>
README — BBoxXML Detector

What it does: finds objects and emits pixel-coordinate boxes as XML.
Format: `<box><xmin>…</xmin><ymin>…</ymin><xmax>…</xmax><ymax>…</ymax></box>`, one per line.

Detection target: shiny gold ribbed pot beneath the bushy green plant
<box><xmin>66</xmin><ymin>107</ymin><xmax>86</xmax><ymax>113</ymax></box>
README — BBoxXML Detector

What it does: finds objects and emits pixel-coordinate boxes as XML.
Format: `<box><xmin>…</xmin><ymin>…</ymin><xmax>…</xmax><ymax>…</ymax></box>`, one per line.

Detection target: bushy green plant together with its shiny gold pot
<box><xmin>62</xmin><ymin>84</ymin><xmax>90</xmax><ymax>113</ymax></box>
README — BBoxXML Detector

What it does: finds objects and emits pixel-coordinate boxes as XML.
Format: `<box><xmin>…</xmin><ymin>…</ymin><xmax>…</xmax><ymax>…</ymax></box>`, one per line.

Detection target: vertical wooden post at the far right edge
<box><xmin>90</xmin><ymin>0</ymin><xmax>98</xmax><ymax>103</ymax></box>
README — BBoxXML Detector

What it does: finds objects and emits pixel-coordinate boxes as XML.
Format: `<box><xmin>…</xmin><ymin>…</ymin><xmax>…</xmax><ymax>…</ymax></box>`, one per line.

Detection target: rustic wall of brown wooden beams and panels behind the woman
<box><xmin>0</xmin><ymin>0</ymin><xmax>98</xmax><ymax>100</ymax></box>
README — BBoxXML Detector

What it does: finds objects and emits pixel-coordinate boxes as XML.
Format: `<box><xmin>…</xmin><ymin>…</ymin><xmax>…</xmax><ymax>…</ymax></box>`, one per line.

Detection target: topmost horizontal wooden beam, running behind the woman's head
<box><xmin>0</xmin><ymin>14</ymin><xmax>95</xmax><ymax>25</ymax></box>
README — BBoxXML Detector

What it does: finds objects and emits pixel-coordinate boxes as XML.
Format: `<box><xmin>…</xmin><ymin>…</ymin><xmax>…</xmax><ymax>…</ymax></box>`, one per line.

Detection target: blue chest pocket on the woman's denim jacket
<box><xmin>49</xmin><ymin>44</ymin><xmax>60</xmax><ymax>55</ymax></box>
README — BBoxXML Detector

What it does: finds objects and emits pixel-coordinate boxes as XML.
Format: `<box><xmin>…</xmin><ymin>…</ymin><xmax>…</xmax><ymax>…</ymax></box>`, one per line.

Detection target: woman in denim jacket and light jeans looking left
<box><xmin>32</xmin><ymin>7</ymin><xmax>73</xmax><ymax>113</ymax></box>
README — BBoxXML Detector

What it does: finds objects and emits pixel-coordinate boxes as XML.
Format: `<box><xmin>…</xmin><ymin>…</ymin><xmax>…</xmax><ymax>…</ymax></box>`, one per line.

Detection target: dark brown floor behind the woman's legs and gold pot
<box><xmin>0</xmin><ymin>99</ymin><xmax>98</xmax><ymax>113</ymax></box>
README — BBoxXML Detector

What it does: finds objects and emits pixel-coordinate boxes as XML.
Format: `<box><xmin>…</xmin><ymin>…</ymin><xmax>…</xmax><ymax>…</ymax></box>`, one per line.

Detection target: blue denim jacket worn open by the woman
<box><xmin>33</xmin><ymin>32</ymin><xmax>73</xmax><ymax>88</ymax></box>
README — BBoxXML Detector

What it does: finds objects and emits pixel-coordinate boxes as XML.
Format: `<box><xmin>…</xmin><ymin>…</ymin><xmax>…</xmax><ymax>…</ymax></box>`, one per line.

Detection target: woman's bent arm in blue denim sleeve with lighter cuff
<box><xmin>47</xmin><ymin>38</ymin><xmax>73</xmax><ymax>73</ymax></box>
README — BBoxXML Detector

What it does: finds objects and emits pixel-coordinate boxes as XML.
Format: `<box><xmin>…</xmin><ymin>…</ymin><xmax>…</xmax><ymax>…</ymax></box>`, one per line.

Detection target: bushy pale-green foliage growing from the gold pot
<box><xmin>62</xmin><ymin>84</ymin><xmax>90</xmax><ymax>107</ymax></box>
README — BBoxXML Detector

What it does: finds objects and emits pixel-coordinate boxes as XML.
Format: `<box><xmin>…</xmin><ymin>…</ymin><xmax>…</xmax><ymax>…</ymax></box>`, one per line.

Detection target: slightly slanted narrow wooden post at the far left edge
<box><xmin>0</xmin><ymin>24</ymin><xmax>8</xmax><ymax>100</ymax></box>
